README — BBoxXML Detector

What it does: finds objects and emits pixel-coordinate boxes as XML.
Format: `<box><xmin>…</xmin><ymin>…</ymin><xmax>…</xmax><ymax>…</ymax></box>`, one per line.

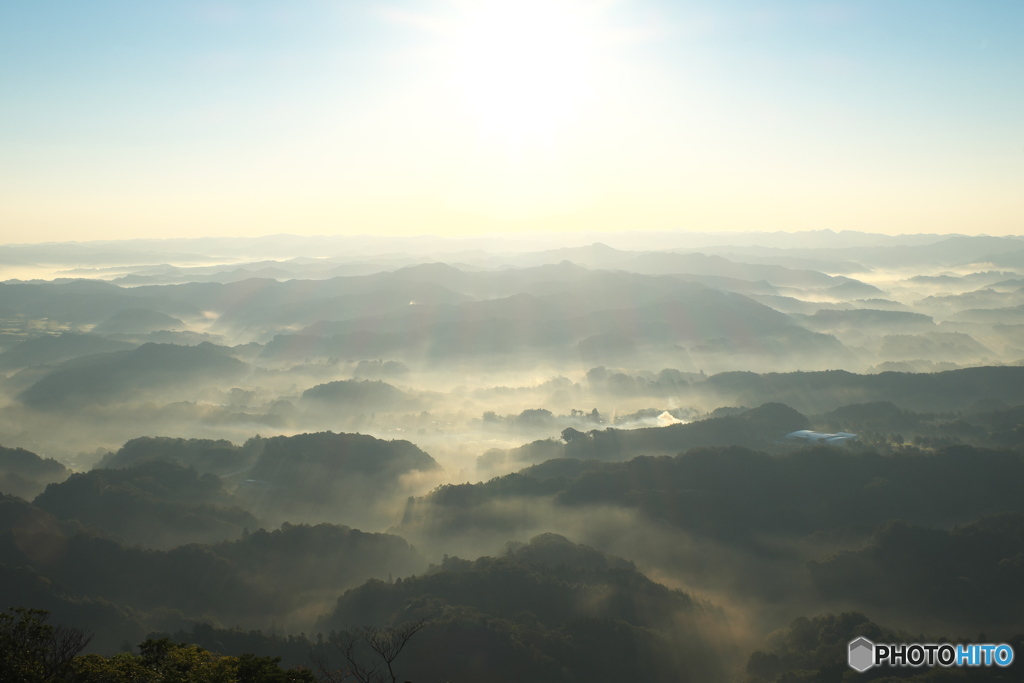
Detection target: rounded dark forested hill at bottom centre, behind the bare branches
<box><xmin>324</xmin><ymin>535</ymin><xmax>727</xmax><ymax>683</ymax></box>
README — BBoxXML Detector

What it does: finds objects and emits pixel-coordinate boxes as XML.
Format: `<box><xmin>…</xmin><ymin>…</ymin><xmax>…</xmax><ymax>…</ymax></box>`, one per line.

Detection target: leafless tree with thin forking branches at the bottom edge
<box><xmin>312</xmin><ymin>618</ymin><xmax>427</xmax><ymax>683</ymax></box>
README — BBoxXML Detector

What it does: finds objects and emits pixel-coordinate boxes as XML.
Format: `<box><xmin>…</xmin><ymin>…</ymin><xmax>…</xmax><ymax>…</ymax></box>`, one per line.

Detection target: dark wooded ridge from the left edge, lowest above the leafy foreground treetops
<box><xmin>0</xmin><ymin>491</ymin><xmax>423</xmax><ymax>634</ymax></box>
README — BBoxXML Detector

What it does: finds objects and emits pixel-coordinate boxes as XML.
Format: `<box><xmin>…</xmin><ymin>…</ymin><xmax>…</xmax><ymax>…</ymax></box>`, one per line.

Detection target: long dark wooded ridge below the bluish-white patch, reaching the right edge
<box><xmin>434</xmin><ymin>444</ymin><xmax>1024</xmax><ymax>543</ymax></box>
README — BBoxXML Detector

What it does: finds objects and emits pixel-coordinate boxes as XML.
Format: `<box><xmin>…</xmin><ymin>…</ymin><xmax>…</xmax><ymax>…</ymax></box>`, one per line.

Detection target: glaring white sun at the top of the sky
<box><xmin>449</xmin><ymin>0</ymin><xmax>596</xmax><ymax>147</ymax></box>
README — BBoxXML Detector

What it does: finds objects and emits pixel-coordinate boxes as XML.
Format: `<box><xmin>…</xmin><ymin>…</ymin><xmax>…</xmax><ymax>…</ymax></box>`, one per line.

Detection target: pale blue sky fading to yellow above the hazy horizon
<box><xmin>0</xmin><ymin>0</ymin><xmax>1024</xmax><ymax>243</ymax></box>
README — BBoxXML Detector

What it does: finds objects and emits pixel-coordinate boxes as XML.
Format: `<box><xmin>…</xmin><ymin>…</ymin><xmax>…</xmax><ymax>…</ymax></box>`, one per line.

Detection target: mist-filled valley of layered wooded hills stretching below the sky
<box><xmin>0</xmin><ymin>230</ymin><xmax>1024</xmax><ymax>683</ymax></box>
